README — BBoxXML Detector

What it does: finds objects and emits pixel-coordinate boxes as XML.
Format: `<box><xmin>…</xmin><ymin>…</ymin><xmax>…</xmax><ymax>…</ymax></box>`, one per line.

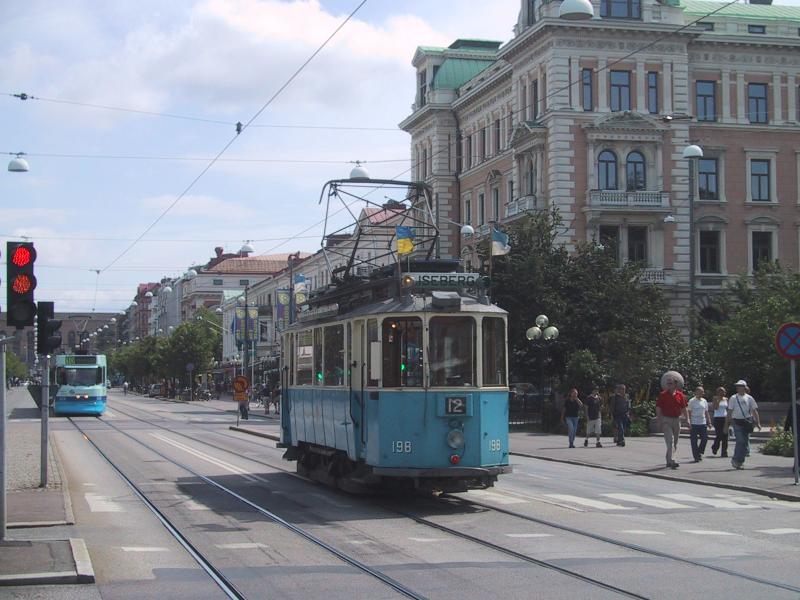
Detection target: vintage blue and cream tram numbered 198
<box><xmin>281</xmin><ymin>260</ymin><xmax>511</xmax><ymax>492</ymax></box>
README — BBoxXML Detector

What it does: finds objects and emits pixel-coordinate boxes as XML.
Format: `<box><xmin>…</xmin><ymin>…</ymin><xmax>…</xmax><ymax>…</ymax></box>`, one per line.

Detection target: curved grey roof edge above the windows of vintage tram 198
<box><xmin>289</xmin><ymin>294</ymin><xmax>506</xmax><ymax>329</ymax></box>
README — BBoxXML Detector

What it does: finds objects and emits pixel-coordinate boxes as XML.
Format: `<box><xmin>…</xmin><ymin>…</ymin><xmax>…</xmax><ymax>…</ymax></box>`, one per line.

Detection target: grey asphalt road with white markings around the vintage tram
<box><xmin>40</xmin><ymin>392</ymin><xmax>800</xmax><ymax>600</ymax></box>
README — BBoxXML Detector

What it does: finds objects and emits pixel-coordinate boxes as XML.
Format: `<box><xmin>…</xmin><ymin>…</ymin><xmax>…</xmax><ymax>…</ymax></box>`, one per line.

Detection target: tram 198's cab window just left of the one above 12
<box><xmin>382</xmin><ymin>317</ymin><xmax>422</xmax><ymax>387</ymax></box>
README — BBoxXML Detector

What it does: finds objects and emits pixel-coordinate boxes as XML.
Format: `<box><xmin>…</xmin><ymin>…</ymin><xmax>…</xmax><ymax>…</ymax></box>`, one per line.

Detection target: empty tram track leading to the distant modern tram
<box><xmin>68</xmin><ymin>411</ymin><xmax>427</xmax><ymax>600</ymax></box>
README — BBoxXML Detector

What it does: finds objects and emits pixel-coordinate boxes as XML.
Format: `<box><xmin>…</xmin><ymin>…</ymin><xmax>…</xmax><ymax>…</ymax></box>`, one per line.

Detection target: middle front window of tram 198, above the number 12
<box><xmin>428</xmin><ymin>317</ymin><xmax>476</xmax><ymax>387</ymax></box>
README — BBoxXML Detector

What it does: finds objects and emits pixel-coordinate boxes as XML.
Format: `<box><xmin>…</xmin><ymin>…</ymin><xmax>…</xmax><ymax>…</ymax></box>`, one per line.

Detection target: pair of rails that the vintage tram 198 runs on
<box><xmin>101</xmin><ymin>398</ymin><xmax>800</xmax><ymax>598</ymax></box>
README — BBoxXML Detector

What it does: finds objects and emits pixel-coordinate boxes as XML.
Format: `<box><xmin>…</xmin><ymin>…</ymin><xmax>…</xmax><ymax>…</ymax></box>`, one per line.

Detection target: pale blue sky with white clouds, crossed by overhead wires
<box><xmin>0</xmin><ymin>0</ymin><xmax>800</xmax><ymax>312</ymax></box>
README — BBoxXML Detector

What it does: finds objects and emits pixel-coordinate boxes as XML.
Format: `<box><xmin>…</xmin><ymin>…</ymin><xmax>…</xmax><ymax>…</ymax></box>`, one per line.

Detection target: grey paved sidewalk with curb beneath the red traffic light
<box><xmin>0</xmin><ymin>387</ymin><xmax>94</xmax><ymax>586</ymax></box>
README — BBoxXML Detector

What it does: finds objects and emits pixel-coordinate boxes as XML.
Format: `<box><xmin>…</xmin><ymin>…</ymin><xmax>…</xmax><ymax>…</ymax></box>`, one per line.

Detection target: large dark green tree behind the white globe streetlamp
<box><xmin>482</xmin><ymin>210</ymin><xmax>682</xmax><ymax>393</ymax></box>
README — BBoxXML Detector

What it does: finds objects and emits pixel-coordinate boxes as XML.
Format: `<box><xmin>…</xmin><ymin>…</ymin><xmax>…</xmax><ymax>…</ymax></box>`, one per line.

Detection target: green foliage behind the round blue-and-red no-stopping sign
<box><xmin>701</xmin><ymin>264</ymin><xmax>800</xmax><ymax>401</ymax></box>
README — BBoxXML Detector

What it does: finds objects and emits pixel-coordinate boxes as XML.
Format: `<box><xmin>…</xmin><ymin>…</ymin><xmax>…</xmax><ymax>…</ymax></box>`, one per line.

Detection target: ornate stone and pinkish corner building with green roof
<box><xmin>401</xmin><ymin>0</ymin><xmax>800</xmax><ymax>329</ymax></box>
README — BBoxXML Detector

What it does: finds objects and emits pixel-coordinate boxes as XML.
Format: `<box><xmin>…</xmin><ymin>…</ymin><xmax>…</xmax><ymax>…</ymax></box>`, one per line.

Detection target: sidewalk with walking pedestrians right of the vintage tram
<box><xmin>509</xmin><ymin>432</ymin><xmax>800</xmax><ymax>502</ymax></box>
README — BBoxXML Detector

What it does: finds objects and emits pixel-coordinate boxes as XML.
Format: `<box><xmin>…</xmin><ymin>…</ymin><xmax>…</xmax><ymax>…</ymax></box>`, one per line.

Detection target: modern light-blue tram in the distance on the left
<box><xmin>51</xmin><ymin>354</ymin><xmax>108</xmax><ymax>415</ymax></box>
